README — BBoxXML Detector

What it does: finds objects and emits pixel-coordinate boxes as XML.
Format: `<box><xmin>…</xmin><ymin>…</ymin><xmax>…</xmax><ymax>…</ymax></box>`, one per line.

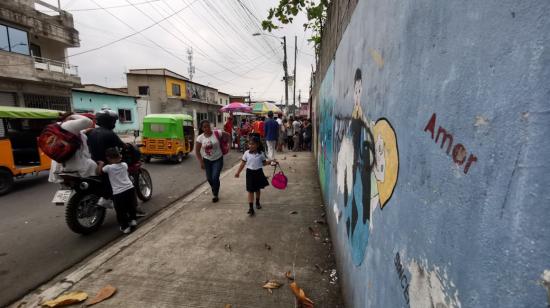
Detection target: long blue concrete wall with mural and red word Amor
<box><xmin>313</xmin><ymin>0</ymin><xmax>550</xmax><ymax>308</ymax></box>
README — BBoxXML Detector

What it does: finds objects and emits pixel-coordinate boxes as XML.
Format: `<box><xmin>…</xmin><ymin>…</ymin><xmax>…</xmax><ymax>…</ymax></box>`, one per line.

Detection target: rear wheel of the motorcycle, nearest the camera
<box><xmin>65</xmin><ymin>193</ymin><xmax>105</xmax><ymax>235</ymax></box>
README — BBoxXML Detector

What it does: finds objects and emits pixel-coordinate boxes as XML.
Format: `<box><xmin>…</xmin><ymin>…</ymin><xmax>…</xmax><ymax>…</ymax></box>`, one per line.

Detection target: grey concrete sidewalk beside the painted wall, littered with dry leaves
<box><xmin>13</xmin><ymin>153</ymin><xmax>343</xmax><ymax>308</ymax></box>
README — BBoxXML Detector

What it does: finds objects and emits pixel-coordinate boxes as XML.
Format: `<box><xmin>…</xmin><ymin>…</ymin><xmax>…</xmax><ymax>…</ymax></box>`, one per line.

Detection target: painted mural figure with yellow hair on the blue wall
<box><xmin>333</xmin><ymin>69</ymin><xmax>398</xmax><ymax>266</ymax></box>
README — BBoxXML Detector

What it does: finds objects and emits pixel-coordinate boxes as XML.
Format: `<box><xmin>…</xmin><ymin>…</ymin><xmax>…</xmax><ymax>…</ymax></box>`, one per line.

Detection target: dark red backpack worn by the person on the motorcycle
<box><xmin>38</xmin><ymin>123</ymin><xmax>82</xmax><ymax>163</ymax></box>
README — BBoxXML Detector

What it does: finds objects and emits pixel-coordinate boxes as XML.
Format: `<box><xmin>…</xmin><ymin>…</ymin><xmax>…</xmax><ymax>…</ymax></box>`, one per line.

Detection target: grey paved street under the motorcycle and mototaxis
<box><xmin>0</xmin><ymin>152</ymin><xmax>244</xmax><ymax>306</ymax></box>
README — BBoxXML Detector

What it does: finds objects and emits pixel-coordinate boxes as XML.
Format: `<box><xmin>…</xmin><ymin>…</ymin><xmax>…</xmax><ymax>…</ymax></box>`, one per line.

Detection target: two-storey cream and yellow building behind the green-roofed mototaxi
<box><xmin>126</xmin><ymin>68</ymin><xmax>229</xmax><ymax>127</ymax></box>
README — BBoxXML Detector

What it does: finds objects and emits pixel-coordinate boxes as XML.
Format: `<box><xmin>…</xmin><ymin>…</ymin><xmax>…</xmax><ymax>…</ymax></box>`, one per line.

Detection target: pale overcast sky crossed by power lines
<box><xmin>41</xmin><ymin>0</ymin><xmax>315</xmax><ymax>104</ymax></box>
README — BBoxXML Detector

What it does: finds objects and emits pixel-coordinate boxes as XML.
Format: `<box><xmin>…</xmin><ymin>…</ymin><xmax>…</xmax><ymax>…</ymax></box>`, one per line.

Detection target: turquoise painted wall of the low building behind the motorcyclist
<box><xmin>73</xmin><ymin>91</ymin><xmax>139</xmax><ymax>134</ymax></box>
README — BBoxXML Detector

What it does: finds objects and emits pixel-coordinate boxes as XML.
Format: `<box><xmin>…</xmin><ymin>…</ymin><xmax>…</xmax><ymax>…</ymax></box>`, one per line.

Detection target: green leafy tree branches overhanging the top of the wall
<box><xmin>262</xmin><ymin>0</ymin><xmax>329</xmax><ymax>54</ymax></box>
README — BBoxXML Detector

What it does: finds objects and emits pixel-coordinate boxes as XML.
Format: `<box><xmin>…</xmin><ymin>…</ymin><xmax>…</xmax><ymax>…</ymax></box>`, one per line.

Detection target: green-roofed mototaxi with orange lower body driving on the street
<box><xmin>141</xmin><ymin>114</ymin><xmax>195</xmax><ymax>163</ymax></box>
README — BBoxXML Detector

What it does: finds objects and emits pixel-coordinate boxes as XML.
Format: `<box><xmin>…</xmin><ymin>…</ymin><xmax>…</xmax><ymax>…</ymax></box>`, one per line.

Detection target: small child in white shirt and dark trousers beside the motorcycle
<box><xmin>98</xmin><ymin>148</ymin><xmax>137</xmax><ymax>234</ymax></box>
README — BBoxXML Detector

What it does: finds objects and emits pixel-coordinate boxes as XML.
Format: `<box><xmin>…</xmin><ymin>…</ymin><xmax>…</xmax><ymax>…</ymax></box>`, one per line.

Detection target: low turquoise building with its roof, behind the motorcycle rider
<box><xmin>72</xmin><ymin>84</ymin><xmax>138</xmax><ymax>134</ymax></box>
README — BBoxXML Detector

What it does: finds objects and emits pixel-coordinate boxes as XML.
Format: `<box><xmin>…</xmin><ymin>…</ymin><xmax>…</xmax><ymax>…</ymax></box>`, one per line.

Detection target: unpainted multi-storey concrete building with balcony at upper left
<box><xmin>0</xmin><ymin>0</ymin><xmax>80</xmax><ymax>110</ymax></box>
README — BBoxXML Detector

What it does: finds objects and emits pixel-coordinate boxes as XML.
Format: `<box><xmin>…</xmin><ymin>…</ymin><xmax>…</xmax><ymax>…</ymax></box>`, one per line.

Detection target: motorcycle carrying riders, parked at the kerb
<box><xmin>52</xmin><ymin>146</ymin><xmax>153</xmax><ymax>234</ymax></box>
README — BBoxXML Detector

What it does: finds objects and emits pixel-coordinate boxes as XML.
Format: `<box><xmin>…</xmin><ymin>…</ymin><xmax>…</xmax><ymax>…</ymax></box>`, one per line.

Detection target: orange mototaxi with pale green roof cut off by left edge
<box><xmin>0</xmin><ymin>106</ymin><xmax>61</xmax><ymax>195</ymax></box>
